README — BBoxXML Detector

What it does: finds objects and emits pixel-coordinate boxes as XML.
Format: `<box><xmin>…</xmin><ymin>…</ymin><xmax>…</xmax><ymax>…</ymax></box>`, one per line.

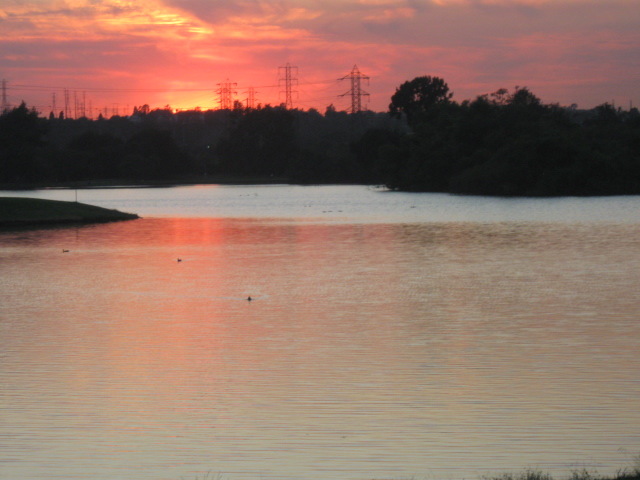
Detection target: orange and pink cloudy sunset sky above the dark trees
<box><xmin>0</xmin><ymin>0</ymin><xmax>640</xmax><ymax>116</ymax></box>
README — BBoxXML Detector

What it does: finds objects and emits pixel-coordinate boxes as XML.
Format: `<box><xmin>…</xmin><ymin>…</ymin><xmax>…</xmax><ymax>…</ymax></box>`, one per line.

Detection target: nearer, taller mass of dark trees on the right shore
<box><xmin>376</xmin><ymin>77</ymin><xmax>640</xmax><ymax>196</ymax></box>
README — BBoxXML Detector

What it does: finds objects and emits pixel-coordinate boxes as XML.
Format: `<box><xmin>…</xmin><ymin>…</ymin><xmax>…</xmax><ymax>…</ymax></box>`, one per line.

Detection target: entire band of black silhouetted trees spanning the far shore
<box><xmin>0</xmin><ymin>77</ymin><xmax>640</xmax><ymax>195</ymax></box>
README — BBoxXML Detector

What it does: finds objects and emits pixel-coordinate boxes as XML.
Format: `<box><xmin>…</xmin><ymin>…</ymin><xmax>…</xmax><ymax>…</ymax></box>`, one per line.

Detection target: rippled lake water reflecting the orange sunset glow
<box><xmin>0</xmin><ymin>185</ymin><xmax>640</xmax><ymax>480</ymax></box>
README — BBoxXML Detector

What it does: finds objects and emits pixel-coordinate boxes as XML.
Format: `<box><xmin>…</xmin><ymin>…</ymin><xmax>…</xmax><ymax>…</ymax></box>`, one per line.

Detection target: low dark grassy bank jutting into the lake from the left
<box><xmin>0</xmin><ymin>197</ymin><xmax>138</xmax><ymax>227</ymax></box>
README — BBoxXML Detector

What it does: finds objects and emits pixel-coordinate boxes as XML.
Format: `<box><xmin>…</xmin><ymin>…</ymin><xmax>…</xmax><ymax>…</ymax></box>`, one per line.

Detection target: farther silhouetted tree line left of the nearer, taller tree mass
<box><xmin>0</xmin><ymin>103</ymin><xmax>406</xmax><ymax>187</ymax></box>
